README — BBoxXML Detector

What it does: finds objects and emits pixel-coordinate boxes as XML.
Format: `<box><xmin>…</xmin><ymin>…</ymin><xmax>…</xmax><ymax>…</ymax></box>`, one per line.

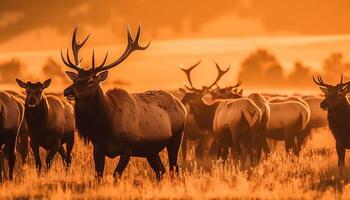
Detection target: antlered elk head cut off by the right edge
<box><xmin>312</xmin><ymin>76</ymin><xmax>350</xmax><ymax>110</ymax></box>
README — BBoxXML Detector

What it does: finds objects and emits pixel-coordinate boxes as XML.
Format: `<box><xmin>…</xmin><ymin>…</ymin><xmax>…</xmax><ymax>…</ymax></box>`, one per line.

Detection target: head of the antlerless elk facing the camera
<box><xmin>16</xmin><ymin>79</ymin><xmax>51</xmax><ymax>108</ymax></box>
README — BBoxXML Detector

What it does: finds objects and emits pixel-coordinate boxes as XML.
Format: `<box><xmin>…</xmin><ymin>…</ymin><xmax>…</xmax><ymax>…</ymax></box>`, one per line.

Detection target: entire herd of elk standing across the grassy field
<box><xmin>0</xmin><ymin>26</ymin><xmax>350</xmax><ymax>180</ymax></box>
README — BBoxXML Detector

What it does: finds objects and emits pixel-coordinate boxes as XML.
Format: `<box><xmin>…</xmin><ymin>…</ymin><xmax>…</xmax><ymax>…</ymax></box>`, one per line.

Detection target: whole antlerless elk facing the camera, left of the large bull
<box><xmin>16</xmin><ymin>79</ymin><xmax>74</xmax><ymax>174</ymax></box>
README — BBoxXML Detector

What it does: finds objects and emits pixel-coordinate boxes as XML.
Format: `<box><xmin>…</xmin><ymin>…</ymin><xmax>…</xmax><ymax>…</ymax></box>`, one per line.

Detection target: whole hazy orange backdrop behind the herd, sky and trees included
<box><xmin>0</xmin><ymin>0</ymin><xmax>350</xmax><ymax>91</ymax></box>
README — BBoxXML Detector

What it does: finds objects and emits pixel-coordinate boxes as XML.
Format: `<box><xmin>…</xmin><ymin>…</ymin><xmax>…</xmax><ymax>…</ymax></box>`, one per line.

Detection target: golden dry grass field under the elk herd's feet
<box><xmin>0</xmin><ymin>129</ymin><xmax>350</xmax><ymax>199</ymax></box>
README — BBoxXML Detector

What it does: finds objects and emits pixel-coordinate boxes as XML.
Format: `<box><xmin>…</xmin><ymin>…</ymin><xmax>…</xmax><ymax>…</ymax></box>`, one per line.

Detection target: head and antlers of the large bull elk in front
<box><xmin>61</xmin><ymin>26</ymin><xmax>150</xmax><ymax>100</ymax></box>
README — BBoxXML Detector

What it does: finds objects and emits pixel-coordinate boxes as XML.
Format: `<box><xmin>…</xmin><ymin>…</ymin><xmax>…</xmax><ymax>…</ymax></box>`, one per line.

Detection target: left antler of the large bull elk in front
<box><xmin>61</xmin><ymin>27</ymin><xmax>90</xmax><ymax>71</ymax></box>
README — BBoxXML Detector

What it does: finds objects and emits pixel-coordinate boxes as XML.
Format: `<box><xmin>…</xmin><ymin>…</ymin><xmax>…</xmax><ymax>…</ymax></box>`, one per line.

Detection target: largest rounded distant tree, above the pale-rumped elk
<box><xmin>239</xmin><ymin>49</ymin><xmax>284</xmax><ymax>87</ymax></box>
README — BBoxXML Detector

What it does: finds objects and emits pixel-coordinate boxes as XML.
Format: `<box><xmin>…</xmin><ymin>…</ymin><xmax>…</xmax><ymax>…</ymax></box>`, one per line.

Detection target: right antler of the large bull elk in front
<box><xmin>94</xmin><ymin>25</ymin><xmax>151</xmax><ymax>73</ymax></box>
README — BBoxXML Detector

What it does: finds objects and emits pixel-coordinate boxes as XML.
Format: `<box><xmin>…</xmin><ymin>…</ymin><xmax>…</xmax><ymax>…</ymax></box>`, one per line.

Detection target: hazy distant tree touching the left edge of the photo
<box><xmin>0</xmin><ymin>59</ymin><xmax>22</xmax><ymax>83</ymax></box>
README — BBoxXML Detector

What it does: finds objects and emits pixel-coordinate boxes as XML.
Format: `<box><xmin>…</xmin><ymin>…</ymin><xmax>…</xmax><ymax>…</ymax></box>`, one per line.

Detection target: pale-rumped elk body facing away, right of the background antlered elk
<box><xmin>206</xmin><ymin>98</ymin><xmax>262</xmax><ymax>162</ymax></box>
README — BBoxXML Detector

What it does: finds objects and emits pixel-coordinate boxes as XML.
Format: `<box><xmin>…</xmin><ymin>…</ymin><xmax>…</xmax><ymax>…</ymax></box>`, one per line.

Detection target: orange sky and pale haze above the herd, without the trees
<box><xmin>0</xmin><ymin>0</ymin><xmax>350</xmax><ymax>89</ymax></box>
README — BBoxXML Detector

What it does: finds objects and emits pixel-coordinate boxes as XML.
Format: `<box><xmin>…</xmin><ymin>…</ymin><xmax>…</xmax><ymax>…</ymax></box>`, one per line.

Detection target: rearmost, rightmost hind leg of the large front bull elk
<box><xmin>167</xmin><ymin>130</ymin><xmax>183</xmax><ymax>174</ymax></box>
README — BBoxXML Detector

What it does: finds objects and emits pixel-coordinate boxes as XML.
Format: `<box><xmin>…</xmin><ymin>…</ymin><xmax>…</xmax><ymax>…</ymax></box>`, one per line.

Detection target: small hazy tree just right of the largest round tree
<box><xmin>287</xmin><ymin>61</ymin><xmax>313</xmax><ymax>88</ymax></box>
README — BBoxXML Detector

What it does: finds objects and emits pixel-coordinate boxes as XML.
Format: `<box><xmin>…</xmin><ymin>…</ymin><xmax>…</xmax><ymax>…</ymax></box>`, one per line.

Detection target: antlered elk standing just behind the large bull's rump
<box><xmin>180</xmin><ymin>61</ymin><xmax>239</xmax><ymax>161</ymax></box>
